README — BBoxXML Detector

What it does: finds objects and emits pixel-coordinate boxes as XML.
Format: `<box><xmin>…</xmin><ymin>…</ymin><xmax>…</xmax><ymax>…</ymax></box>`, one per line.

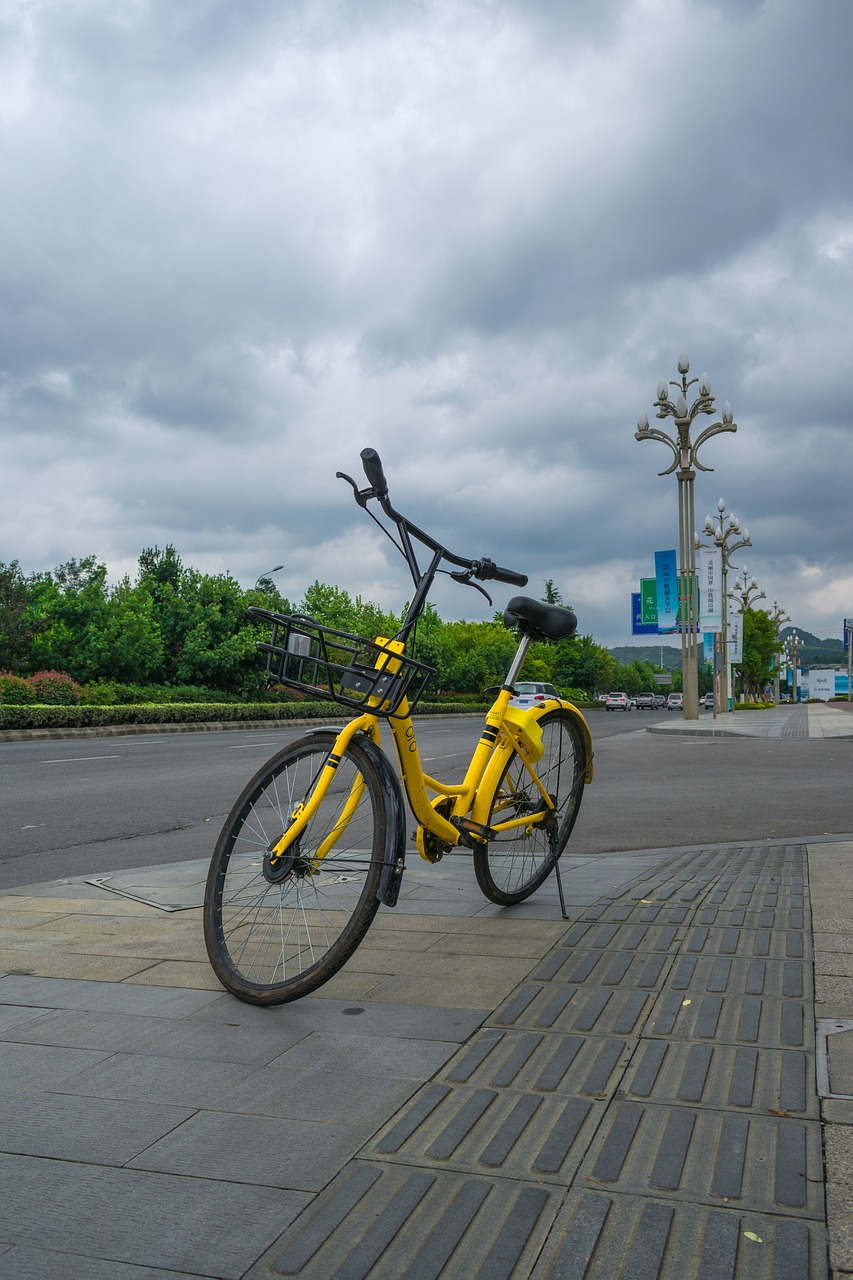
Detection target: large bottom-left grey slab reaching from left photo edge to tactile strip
<box><xmin>0</xmin><ymin>1152</ymin><xmax>306</xmax><ymax>1280</ymax></box>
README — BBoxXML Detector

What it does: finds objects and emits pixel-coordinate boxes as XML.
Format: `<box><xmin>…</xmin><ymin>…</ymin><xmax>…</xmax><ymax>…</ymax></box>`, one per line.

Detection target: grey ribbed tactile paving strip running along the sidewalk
<box><xmin>251</xmin><ymin>845</ymin><xmax>827</xmax><ymax>1280</ymax></box>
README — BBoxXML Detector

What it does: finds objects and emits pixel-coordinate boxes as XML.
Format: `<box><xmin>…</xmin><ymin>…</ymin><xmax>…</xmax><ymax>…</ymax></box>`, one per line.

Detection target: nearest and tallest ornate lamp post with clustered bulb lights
<box><xmin>634</xmin><ymin>352</ymin><xmax>738</xmax><ymax>719</ymax></box>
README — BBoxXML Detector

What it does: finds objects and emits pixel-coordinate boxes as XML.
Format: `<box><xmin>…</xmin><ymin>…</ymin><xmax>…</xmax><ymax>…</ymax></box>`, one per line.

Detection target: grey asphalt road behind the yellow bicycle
<box><xmin>0</xmin><ymin>710</ymin><xmax>853</xmax><ymax>891</ymax></box>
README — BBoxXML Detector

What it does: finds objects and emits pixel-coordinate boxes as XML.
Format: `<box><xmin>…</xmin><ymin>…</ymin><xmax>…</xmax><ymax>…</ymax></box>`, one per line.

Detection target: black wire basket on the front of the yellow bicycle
<box><xmin>248</xmin><ymin>605</ymin><xmax>435</xmax><ymax>717</ymax></box>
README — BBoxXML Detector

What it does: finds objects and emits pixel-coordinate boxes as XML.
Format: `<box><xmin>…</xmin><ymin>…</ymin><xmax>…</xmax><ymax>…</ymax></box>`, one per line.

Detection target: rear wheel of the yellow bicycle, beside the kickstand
<box><xmin>474</xmin><ymin>708</ymin><xmax>587</xmax><ymax>906</ymax></box>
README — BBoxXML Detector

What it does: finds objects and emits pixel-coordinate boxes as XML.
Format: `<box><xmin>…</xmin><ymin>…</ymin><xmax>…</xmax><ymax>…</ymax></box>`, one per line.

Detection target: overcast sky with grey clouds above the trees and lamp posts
<box><xmin>0</xmin><ymin>0</ymin><xmax>853</xmax><ymax>645</ymax></box>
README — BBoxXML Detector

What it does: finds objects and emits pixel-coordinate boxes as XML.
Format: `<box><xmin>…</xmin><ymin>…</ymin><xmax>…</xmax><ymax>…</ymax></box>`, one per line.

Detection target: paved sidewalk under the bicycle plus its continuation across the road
<box><xmin>0</xmin><ymin>704</ymin><xmax>853</xmax><ymax>1280</ymax></box>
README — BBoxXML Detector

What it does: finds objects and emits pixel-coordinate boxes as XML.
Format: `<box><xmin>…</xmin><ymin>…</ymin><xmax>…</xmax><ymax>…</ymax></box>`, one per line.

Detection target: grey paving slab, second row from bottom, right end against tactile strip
<box><xmin>127</xmin><ymin>1111</ymin><xmax>377</xmax><ymax>1192</ymax></box>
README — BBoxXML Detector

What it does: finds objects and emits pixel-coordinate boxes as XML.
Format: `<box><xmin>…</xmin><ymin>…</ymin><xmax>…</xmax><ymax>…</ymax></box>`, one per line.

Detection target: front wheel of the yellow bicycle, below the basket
<box><xmin>204</xmin><ymin>732</ymin><xmax>387</xmax><ymax>1005</ymax></box>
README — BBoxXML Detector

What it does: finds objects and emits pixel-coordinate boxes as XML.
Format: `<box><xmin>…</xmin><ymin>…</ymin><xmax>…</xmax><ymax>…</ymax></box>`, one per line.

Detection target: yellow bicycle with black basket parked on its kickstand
<box><xmin>204</xmin><ymin>449</ymin><xmax>593</xmax><ymax>1005</ymax></box>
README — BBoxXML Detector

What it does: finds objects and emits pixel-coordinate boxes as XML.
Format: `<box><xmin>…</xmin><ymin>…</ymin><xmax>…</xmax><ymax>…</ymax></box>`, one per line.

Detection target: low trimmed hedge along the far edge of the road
<box><xmin>0</xmin><ymin>701</ymin><xmax>471</xmax><ymax>730</ymax></box>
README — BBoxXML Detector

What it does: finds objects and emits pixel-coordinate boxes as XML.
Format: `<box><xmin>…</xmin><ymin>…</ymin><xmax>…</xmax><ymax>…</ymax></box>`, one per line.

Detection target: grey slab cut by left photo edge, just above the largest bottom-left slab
<box><xmin>0</xmin><ymin>1092</ymin><xmax>192</xmax><ymax>1165</ymax></box>
